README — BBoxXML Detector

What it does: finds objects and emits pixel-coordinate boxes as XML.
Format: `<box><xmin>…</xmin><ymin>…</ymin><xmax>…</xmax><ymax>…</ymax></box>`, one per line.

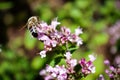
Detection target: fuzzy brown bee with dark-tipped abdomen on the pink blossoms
<box><xmin>20</xmin><ymin>16</ymin><xmax>39</xmax><ymax>38</ymax></box>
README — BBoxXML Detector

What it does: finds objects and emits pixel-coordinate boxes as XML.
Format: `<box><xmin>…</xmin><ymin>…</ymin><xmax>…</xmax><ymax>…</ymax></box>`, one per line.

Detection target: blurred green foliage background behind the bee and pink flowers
<box><xmin>0</xmin><ymin>0</ymin><xmax>120</xmax><ymax>80</ymax></box>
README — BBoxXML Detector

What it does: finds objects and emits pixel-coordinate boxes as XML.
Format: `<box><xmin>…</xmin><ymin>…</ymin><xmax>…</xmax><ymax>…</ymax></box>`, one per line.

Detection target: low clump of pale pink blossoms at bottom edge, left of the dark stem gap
<box><xmin>40</xmin><ymin>65</ymin><xmax>67</xmax><ymax>80</ymax></box>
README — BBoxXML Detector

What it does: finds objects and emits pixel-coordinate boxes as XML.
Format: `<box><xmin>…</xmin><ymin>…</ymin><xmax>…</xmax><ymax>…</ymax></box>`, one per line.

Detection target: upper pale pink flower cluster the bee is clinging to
<box><xmin>36</xmin><ymin>18</ymin><xmax>82</xmax><ymax>58</ymax></box>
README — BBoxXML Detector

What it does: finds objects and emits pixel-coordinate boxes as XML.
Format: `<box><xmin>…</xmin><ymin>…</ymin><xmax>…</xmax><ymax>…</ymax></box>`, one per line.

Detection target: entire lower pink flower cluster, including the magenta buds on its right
<box><xmin>40</xmin><ymin>52</ymin><xmax>95</xmax><ymax>80</ymax></box>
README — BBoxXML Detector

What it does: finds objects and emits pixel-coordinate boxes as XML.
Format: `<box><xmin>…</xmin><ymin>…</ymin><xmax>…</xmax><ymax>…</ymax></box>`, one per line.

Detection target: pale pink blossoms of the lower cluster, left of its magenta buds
<box><xmin>40</xmin><ymin>52</ymin><xmax>77</xmax><ymax>80</ymax></box>
